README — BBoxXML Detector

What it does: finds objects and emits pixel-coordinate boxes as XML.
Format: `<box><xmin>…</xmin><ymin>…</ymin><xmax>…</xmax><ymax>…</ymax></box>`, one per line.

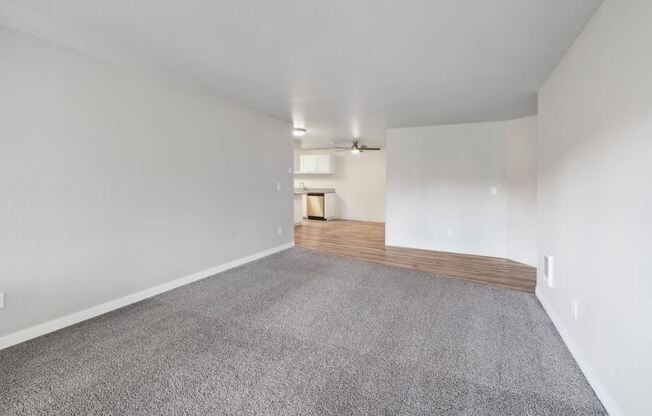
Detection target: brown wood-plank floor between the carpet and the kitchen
<box><xmin>294</xmin><ymin>220</ymin><xmax>536</xmax><ymax>292</ymax></box>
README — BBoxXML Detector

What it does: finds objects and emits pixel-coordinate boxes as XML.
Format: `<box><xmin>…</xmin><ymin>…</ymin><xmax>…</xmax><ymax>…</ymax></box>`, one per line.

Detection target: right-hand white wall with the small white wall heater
<box><xmin>537</xmin><ymin>0</ymin><xmax>652</xmax><ymax>416</ymax></box>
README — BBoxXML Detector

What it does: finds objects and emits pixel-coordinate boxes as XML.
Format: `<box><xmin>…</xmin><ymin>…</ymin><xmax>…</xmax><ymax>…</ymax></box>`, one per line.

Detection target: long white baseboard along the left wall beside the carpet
<box><xmin>0</xmin><ymin>241</ymin><xmax>294</xmax><ymax>350</ymax></box>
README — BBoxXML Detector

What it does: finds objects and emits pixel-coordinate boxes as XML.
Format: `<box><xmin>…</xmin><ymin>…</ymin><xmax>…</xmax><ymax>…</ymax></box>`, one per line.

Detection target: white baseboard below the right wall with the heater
<box><xmin>535</xmin><ymin>287</ymin><xmax>623</xmax><ymax>416</ymax></box>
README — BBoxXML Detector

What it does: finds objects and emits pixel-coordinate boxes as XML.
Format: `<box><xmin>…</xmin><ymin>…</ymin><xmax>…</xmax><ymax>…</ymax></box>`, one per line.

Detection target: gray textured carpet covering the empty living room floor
<box><xmin>0</xmin><ymin>248</ymin><xmax>606</xmax><ymax>416</ymax></box>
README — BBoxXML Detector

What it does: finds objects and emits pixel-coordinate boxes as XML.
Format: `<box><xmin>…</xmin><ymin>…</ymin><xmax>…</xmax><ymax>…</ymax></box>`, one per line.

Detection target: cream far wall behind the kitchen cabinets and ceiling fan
<box><xmin>294</xmin><ymin>149</ymin><xmax>387</xmax><ymax>222</ymax></box>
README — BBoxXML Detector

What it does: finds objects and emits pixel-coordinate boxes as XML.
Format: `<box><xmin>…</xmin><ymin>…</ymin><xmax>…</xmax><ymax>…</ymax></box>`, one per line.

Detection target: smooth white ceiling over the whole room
<box><xmin>0</xmin><ymin>0</ymin><xmax>602</xmax><ymax>142</ymax></box>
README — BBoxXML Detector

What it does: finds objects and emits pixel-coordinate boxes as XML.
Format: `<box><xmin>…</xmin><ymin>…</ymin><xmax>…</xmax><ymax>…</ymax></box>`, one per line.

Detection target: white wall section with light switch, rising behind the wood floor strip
<box><xmin>386</xmin><ymin>117</ymin><xmax>536</xmax><ymax>264</ymax></box>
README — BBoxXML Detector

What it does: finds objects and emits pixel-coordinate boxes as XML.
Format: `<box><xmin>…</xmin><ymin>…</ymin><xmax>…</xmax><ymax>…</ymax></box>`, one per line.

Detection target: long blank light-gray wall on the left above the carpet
<box><xmin>0</xmin><ymin>28</ymin><xmax>292</xmax><ymax>336</ymax></box>
